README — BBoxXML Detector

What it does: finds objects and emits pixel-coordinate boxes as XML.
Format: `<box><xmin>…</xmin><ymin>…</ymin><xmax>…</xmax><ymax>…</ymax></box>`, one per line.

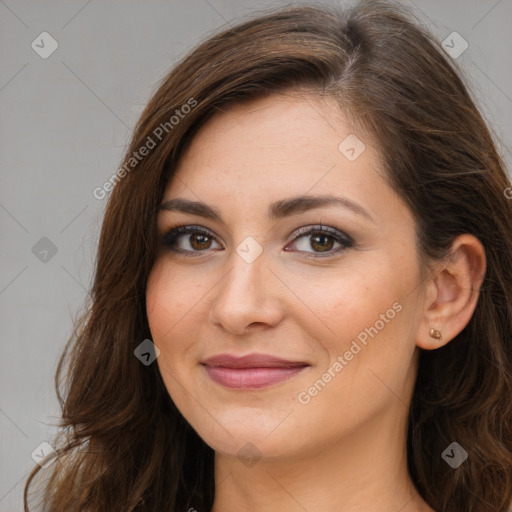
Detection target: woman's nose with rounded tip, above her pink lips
<box><xmin>209</xmin><ymin>247</ymin><xmax>284</xmax><ymax>335</ymax></box>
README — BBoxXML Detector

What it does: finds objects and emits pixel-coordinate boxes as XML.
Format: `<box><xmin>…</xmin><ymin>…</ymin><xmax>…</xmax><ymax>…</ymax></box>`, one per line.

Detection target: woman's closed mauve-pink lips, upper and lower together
<box><xmin>201</xmin><ymin>354</ymin><xmax>310</xmax><ymax>390</ymax></box>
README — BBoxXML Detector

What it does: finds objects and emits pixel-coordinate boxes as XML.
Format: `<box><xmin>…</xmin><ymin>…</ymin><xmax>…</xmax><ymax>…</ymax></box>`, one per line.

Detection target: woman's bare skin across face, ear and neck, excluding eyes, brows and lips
<box><xmin>147</xmin><ymin>93</ymin><xmax>485</xmax><ymax>512</ymax></box>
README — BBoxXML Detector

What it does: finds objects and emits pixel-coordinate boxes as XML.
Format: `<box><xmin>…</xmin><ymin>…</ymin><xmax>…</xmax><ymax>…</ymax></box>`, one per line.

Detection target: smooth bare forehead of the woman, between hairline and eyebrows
<box><xmin>166</xmin><ymin>93</ymin><xmax>380</xmax><ymax>195</ymax></box>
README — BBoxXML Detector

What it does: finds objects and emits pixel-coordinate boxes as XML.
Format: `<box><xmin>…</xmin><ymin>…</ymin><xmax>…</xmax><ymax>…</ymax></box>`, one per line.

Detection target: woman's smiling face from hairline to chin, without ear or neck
<box><xmin>147</xmin><ymin>91</ymin><xmax>423</xmax><ymax>458</ymax></box>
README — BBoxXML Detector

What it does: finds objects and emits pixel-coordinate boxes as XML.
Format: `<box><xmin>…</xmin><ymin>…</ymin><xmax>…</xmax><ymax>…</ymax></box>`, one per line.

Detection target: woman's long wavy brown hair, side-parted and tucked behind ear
<box><xmin>24</xmin><ymin>1</ymin><xmax>512</xmax><ymax>512</ymax></box>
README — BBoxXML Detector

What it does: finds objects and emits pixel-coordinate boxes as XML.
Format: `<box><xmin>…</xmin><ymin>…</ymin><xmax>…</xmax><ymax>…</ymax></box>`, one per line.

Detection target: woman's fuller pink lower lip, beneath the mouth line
<box><xmin>205</xmin><ymin>366</ymin><xmax>307</xmax><ymax>389</ymax></box>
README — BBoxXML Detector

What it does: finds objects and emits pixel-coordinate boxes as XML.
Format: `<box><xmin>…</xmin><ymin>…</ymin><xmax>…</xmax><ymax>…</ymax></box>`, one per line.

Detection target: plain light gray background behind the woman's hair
<box><xmin>0</xmin><ymin>0</ymin><xmax>512</xmax><ymax>512</ymax></box>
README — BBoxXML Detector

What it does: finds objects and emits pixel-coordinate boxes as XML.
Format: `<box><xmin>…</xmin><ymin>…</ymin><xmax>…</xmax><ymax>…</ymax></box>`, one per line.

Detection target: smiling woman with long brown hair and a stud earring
<box><xmin>25</xmin><ymin>1</ymin><xmax>512</xmax><ymax>512</ymax></box>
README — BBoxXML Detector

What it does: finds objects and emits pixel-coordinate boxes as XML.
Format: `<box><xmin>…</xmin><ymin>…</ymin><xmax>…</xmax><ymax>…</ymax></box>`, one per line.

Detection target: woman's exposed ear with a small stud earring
<box><xmin>416</xmin><ymin>234</ymin><xmax>486</xmax><ymax>350</ymax></box>
